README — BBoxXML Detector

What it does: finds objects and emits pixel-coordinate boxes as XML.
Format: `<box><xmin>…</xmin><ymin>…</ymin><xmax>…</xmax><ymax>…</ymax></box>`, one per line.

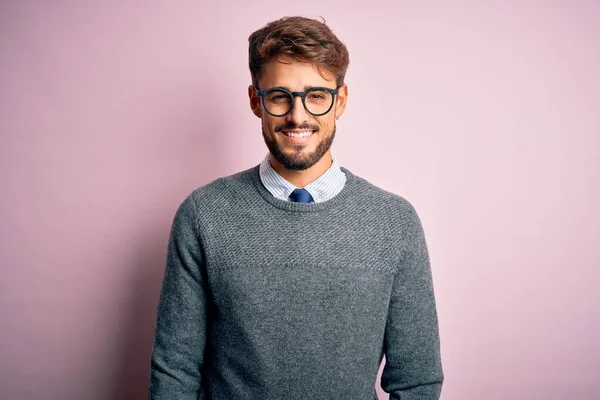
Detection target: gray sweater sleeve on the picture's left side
<box><xmin>148</xmin><ymin>195</ymin><xmax>207</xmax><ymax>400</ymax></box>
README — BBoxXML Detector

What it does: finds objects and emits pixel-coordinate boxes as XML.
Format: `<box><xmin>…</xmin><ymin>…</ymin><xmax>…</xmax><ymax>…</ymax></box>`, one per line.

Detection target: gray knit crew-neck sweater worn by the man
<box><xmin>149</xmin><ymin>166</ymin><xmax>443</xmax><ymax>400</ymax></box>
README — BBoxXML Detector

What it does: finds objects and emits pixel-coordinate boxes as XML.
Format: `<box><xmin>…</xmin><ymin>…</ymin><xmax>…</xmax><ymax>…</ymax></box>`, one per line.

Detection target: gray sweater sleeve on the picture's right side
<box><xmin>381</xmin><ymin>204</ymin><xmax>444</xmax><ymax>400</ymax></box>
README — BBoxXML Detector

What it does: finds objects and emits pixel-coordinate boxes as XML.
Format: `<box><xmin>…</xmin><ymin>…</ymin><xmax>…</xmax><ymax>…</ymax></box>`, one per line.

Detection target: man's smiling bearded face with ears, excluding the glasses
<box><xmin>248</xmin><ymin>61</ymin><xmax>347</xmax><ymax>170</ymax></box>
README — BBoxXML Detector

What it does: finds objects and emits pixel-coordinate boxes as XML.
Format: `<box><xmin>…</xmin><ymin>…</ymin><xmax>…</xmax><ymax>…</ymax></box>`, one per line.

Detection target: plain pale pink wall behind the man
<box><xmin>0</xmin><ymin>0</ymin><xmax>600</xmax><ymax>400</ymax></box>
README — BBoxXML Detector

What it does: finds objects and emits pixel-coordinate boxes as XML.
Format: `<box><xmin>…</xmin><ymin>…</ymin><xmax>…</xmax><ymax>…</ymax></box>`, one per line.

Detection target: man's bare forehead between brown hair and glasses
<box><xmin>258</xmin><ymin>60</ymin><xmax>335</xmax><ymax>91</ymax></box>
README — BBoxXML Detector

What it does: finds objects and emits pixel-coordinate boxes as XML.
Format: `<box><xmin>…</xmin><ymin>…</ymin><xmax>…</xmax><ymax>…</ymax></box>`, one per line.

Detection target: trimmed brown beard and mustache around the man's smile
<box><xmin>262</xmin><ymin>122</ymin><xmax>336</xmax><ymax>171</ymax></box>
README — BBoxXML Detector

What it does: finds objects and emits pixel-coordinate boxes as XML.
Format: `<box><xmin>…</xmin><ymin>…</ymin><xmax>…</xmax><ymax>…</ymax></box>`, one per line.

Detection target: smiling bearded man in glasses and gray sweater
<box><xmin>150</xmin><ymin>17</ymin><xmax>443</xmax><ymax>400</ymax></box>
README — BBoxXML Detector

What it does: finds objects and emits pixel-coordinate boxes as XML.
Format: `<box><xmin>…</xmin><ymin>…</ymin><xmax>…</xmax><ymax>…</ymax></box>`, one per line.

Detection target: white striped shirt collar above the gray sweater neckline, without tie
<box><xmin>259</xmin><ymin>153</ymin><xmax>346</xmax><ymax>203</ymax></box>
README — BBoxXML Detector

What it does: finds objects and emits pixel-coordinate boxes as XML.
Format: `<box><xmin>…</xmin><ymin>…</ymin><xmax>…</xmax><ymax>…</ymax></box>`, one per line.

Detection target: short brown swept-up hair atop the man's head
<box><xmin>248</xmin><ymin>17</ymin><xmax>350</xmax><ymax>88</ymax></box>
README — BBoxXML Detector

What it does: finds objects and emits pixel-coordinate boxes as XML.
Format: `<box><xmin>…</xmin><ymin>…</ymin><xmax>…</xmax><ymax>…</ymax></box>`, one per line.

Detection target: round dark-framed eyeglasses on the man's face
<box><xmin>257</xmin><ymin>87</ymin><xmax>339</xmax><ymax>117</ymax></box>
